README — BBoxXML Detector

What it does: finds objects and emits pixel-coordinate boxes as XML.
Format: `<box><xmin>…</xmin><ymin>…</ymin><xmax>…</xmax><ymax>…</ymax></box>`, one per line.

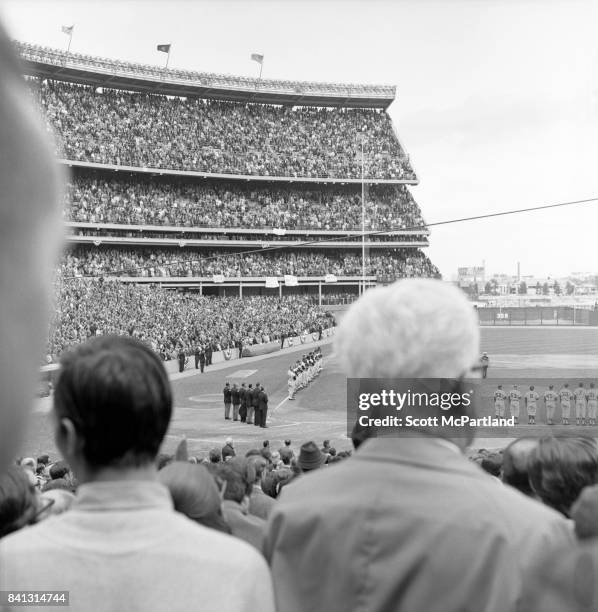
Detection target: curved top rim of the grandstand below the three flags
<box><xmin>13</xmin><ymin>41</ymin><xmax>396</xmax><ymax>109</ymax></box>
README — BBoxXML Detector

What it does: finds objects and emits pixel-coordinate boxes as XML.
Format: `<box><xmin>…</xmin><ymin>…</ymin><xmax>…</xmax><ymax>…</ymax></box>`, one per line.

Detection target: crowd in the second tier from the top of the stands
<box><xmin>65</xmin><ymin>174</ymin><xmax>424</xmax><ymax>230</ymax></box>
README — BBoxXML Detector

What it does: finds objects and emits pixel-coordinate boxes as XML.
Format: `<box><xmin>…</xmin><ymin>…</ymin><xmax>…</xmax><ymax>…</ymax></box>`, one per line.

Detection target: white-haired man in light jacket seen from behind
<box><xmin>264</xmin><ymin>279</ymin><xmax>572</xmax><ymax>612</ymax></box>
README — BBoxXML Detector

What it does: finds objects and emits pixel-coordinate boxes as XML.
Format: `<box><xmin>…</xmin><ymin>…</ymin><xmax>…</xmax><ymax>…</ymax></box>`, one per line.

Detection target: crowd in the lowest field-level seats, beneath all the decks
<box><xmin>46</xmin><ymin>279</ymin><xmax>334</xmax><ymax>363</ymax></box>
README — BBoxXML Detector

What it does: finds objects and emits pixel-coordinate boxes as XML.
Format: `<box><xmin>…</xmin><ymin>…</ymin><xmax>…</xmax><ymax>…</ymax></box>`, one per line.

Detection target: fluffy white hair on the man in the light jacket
<box><xmin>335</xmin><ymin>279</ymin><xmax>479</xmax><ymax>378</ymax></box>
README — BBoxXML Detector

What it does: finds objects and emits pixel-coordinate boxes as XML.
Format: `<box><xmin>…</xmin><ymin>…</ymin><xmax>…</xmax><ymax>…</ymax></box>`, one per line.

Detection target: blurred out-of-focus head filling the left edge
<box><xmin>0</xmin><ymin>24</ymin><xmax>63</xmax><ymax>470</ymax></box>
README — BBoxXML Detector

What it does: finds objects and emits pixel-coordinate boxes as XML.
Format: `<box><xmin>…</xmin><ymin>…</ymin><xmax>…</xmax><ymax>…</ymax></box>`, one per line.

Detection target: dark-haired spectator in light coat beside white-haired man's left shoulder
<box><xmin>214</xmin><ymin>458</ymin><xmax>266</xmax><ymax>552</ymax></box>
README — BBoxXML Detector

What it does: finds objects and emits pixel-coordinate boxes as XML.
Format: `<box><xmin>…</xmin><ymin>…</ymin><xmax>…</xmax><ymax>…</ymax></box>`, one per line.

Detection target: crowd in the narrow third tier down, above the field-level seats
<box><xmin>61</xmin><ymin>246</ymin><xmax>438</xmax><ymax>278</ymax></box>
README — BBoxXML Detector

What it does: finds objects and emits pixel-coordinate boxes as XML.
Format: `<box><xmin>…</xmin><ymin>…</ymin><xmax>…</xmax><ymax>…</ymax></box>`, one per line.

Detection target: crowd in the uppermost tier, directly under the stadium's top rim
<box><xmin>30</xmin><ymin>79</ymin><xmax>415</xmax><ymax>179</ymax></box>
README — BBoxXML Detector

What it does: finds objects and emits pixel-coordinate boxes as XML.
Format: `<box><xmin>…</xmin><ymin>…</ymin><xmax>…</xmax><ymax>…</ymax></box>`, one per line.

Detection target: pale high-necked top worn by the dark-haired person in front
<box><xmin>0</xmin><ymin>482</ymin><xmax>274</xmax><ymax>612</ymax></box>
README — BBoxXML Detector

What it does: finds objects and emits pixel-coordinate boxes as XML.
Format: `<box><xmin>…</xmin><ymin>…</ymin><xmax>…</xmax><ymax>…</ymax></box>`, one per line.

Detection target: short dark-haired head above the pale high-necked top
<box><xmin>54</xmin><ymin>336</ymin><xmax>172</xmax><ymax>471</ymax></box>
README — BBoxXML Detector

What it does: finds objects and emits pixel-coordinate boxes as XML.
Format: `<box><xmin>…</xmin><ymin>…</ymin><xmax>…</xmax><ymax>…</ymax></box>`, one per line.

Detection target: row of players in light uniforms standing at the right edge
<box><xmin>494</xmin><ymin>383</ymin><xmax>598</xmax><ymax>425</ymax></box>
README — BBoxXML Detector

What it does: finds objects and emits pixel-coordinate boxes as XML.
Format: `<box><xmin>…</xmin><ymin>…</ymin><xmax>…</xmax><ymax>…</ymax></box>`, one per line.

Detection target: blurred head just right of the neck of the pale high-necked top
<box><xmin>158</xmin><ymin>461</ymin><xmax>231</xmax><ymax>534</ymax></box>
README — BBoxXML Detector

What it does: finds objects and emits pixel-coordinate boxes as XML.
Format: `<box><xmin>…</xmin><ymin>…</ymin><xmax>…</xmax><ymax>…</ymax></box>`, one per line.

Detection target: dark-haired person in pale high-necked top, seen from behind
<box><xmin>0</xmin><ymin>336</ymin><xmax>272</xmax><ymax>612</ymax></box>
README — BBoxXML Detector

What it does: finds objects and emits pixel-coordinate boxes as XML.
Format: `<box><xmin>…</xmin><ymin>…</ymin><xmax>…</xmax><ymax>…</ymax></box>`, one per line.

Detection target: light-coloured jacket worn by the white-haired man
<box><xmin>264</xmin><ymin>438</ymin><xmax>572</xmax><ymax>612</ymax></box>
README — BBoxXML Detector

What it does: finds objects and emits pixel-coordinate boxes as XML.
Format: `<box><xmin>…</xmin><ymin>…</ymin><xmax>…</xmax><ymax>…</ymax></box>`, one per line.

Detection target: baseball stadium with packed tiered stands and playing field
<box><xmin>10</xmin><ymin>43</ymin><xmax>598</xmax><ymax>455</ymax></box>
